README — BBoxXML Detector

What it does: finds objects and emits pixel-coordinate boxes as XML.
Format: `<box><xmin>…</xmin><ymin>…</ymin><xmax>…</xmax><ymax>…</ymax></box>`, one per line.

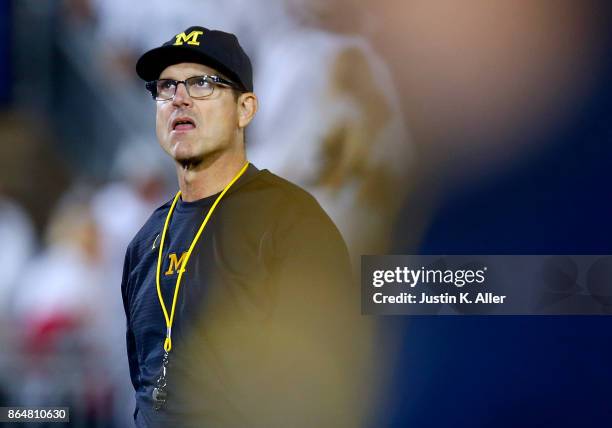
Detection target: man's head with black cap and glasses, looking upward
<box><xmin>136</xmin><ymin>27</ymin><xmax>257</xmax><ymax>166</ymax></box>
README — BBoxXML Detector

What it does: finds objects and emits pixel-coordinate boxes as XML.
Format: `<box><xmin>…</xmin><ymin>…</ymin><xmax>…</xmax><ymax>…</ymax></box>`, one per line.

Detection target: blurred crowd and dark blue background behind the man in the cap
<box><xmin>0</xmin><ymin>0</ymin><xmax>612</xmax><ymax>427</ymax></box>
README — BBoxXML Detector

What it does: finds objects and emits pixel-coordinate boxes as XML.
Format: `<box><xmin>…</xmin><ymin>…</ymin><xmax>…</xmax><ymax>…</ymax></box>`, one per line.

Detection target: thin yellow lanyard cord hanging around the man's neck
<box><xmin>155</xmin><ymin>162</ymin><xmax>249</xmax><ymax>352</ymax></box>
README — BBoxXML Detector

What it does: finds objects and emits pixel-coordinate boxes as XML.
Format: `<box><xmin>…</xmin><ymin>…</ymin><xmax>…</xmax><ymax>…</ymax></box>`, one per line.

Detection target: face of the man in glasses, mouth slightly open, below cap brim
<box><xmin>156</xmin><ymin>63</ymin><xmax>242</xmax><ymax>165</ymax></box>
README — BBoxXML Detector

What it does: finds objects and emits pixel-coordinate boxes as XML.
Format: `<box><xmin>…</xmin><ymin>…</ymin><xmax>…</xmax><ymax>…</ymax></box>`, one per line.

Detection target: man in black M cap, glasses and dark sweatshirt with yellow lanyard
<box><xmin>119</xmin><ymin>27</ymin><xmax>367</xmax><ymax>427</ymax></box>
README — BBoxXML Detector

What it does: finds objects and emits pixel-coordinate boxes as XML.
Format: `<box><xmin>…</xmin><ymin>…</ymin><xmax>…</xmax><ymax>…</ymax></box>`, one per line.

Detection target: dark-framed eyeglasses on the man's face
<box><xmin>145</xmin><ymin>75</ymin><xmax>243</xmax><ymax>101</ymax></box>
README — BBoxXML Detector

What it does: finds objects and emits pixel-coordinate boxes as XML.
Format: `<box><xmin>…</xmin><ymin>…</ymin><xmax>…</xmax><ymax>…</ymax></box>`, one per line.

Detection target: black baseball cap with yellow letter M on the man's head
<box><xmin>136</xmin><ymin>27</ymin><xmax>253</xmax><ymax>92</ymax></box>
